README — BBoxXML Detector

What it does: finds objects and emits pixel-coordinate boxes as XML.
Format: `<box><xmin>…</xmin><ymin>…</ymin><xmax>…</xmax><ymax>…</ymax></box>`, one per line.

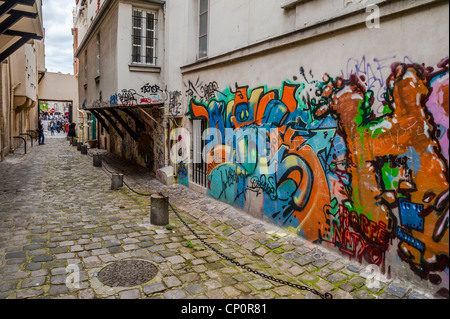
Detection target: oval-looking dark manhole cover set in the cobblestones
<box><xmin>98</xmin><ymin>260</ymin><xmax>158</xmax><ymax>287</ymax></box>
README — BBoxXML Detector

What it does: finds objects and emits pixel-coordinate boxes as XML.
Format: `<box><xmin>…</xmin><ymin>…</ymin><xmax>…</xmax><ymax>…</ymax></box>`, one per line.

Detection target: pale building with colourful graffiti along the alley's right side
<box><xmin>76</xmin><ymin>0</ymin><xmax>449</xmax><ymax>296</ymax></box>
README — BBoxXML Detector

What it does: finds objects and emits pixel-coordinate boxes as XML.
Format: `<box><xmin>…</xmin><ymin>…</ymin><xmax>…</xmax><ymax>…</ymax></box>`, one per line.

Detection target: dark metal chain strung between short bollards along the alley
<box><xmin>88</xmin><ymin>150</ymin><xmax>333</xmax><ymax>299</ymax></box>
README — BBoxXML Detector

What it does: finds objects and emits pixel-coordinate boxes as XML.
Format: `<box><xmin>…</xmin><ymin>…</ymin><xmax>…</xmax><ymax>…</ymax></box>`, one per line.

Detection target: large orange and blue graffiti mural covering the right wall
<box><xmin>184</xmin><ymin>57</ymin><xmax>449</xmax><ymax>293</ymax></box>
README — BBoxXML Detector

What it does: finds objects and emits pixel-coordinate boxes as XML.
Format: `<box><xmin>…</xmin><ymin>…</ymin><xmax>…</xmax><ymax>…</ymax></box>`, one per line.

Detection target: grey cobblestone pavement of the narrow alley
<box><xmin>0</xmin><ymin>138</ymin><xmax>433</xmax><ymax>299</ymax></box>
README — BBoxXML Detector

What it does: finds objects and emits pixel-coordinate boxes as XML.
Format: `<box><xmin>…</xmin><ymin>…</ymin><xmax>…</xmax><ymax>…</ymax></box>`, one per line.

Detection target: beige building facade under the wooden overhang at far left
<box><xmin>0</xmin><ymin>0</ymin><xmax>45</xmax><ymax>161</ymax></box>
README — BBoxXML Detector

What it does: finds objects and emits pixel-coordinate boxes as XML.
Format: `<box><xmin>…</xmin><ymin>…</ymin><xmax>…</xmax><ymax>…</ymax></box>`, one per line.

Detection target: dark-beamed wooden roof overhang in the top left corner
<box><xmin>0</xmin><ymin>0</ymin><xmax>44</xmax><ymax>62</ymax></box>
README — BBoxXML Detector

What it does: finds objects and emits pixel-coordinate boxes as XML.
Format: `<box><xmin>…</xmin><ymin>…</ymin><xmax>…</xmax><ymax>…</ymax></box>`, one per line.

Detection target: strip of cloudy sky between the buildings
<box><xmin>42</xmin><ymin>0</ymin><xmax>75</xmax><ymax>74</ymax></box>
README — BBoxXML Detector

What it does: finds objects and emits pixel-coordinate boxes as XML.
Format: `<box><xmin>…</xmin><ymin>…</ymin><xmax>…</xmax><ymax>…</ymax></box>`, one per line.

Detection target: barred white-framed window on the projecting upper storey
<box><xmin>132</xmin><ymin>9</ymin><xmax>157</xmax><ymax>65</ymax></box>
